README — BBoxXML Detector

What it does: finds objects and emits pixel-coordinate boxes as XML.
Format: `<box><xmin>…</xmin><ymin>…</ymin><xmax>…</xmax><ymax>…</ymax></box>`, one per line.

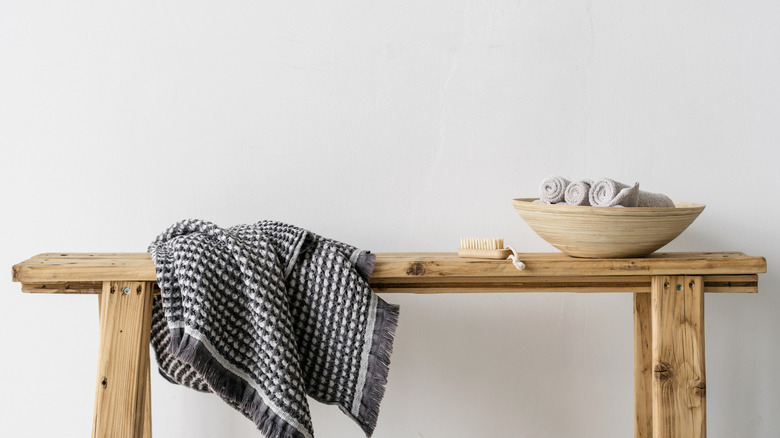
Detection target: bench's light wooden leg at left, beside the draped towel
<box><xmin>92</xmin><ymin>281</ymin><xmax>153</xmax><ymax>438</ymax></box>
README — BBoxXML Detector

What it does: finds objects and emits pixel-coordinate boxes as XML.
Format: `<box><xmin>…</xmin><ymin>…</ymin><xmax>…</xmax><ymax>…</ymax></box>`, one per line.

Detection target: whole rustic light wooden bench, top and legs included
<box><xmin>13</xmin><ymin>252</ymin><xmax>766</xmax><ymax>438</ymax></box>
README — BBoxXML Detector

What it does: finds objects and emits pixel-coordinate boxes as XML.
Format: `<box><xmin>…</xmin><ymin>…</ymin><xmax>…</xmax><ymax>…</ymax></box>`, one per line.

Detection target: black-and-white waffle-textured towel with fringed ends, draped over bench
<box><xmin>149</xmin><ymin>220</ymin><xmax>399</xmax><ymax>438</ymax></box>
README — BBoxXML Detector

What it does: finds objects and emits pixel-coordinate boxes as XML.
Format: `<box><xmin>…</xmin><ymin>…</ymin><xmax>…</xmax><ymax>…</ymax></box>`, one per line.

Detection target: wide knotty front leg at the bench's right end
<box><xmin>651</xmin><ymin>276</ymin><xmax>707</xmax><ymax>438</ymax></box>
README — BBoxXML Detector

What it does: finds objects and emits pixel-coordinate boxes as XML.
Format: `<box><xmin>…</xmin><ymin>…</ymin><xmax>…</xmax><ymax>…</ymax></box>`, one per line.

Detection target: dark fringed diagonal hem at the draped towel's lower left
<box><xmin>171</xmin><ymin>328</ymin><xmax>312</xmax><ymax>438</ymax></box>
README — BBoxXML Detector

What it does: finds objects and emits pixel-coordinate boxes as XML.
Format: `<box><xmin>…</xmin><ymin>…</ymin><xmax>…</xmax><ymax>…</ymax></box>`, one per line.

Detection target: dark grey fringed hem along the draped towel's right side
<box><xmin>354</xmin><ymin>297</ymin><xmax>400</xmax><ymax>437</ymax></box>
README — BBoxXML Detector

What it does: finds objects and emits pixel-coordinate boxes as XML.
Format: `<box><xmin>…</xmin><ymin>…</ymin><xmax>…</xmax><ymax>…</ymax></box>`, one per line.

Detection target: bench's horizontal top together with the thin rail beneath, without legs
<box><xmin>12</xmin><ymin>252</ymin><xmax>766</xmax><ymax>293</ymax></box>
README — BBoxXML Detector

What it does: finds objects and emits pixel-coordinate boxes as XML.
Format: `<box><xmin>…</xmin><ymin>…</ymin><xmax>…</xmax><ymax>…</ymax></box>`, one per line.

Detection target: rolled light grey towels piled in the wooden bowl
<box><xmin>536</xmin><ymin>176</ymin><xmax>674</xmax><ymax>207</ymax></box>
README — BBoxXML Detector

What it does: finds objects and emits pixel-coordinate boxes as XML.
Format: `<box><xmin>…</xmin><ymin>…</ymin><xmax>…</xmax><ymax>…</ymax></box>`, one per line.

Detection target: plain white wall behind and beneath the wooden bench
<box><xmin>0</xmin><ymin>0</ymin><xmax>780</xmax><ymax>438</ymax></box>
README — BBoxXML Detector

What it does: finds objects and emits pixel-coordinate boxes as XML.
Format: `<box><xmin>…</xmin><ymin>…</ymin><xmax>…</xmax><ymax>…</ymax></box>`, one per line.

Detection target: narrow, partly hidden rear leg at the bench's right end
<box><xmin>634</xmin><ymin>293</ymin><xmax>653</xmax><ymax>438</ymax></box>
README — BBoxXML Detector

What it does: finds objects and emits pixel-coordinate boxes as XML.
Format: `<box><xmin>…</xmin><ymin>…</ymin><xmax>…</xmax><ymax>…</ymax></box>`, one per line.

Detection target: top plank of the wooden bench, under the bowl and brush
<box><xmin>12</xmin><ymin>252</ymin><xmax>766</xmax><ymax>284</ymax></box>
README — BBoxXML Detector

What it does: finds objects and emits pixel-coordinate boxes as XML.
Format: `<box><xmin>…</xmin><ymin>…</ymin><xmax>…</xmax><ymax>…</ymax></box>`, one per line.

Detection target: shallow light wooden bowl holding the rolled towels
<box><xmin>512</xmin><ymin>198</ymin><xmax>705</xmax><ymax>258</ymax></box>
